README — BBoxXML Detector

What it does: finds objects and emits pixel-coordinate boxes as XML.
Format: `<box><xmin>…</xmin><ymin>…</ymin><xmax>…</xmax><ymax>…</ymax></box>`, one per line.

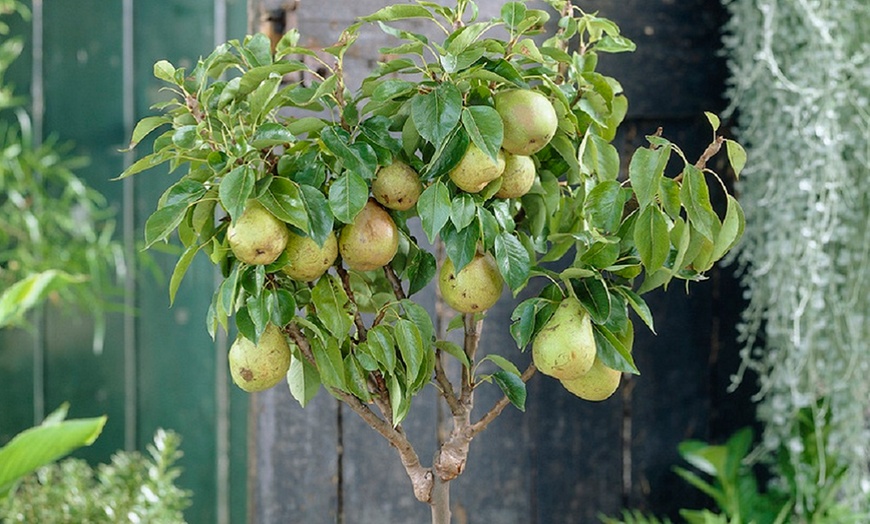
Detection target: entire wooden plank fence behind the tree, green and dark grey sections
<box><xmin>0</xmin><ymin>0</ymin><xmax>751</xmax><ymax>524</ymax></box>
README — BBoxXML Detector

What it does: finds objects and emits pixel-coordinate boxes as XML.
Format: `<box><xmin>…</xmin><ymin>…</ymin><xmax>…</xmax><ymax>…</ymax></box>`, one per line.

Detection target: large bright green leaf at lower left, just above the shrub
<box><xmin>0</xmin><ymin>404</ymin><xmax>106</xmax><ymax>500</ymax></box>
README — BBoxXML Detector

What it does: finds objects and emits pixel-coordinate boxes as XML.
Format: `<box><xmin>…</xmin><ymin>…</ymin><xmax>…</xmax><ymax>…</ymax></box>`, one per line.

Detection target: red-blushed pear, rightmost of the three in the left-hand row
<box><xmin>338</xmin><ymin>199</ymin><xmax>399</xmax><ymax>271</ymax></box>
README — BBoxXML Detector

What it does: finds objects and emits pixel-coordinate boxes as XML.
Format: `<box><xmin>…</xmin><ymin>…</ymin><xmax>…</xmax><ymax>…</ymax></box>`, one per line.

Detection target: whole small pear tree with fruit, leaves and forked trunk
<box><xmin>121</xmin><ymin>0</ymin><xmax>745</xmax><ymax>523</ymax></box>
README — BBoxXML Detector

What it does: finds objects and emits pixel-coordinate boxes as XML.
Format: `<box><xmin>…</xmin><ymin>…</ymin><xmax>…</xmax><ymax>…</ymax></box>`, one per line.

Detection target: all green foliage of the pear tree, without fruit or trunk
<box><xmin>121</xmin><ymin>0</ymin><xmax>744</xmax><ymax>422</ymax></box>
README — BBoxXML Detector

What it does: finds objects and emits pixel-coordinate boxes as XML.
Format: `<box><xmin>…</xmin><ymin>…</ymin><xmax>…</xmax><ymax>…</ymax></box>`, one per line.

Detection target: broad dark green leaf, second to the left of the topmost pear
<box><xmin>411</xmin><ymin>83</ymin><xmax>462</xmax><ymax>149</ymax></box>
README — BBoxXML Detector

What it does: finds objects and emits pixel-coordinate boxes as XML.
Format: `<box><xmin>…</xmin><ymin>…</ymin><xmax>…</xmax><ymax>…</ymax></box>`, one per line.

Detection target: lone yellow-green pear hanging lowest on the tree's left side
<box><xmin>228</xmin><ymin>323</ymin><xmax>290</xmax><ymax>392</ymax></box>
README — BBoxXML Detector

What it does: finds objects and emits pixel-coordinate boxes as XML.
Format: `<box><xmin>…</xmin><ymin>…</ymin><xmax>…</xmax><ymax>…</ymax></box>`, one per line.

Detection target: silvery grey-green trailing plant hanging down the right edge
<box><xmin>723</xmin><ymin>0</ymin><xmax>870</xmax><ymax>514</ymax></box>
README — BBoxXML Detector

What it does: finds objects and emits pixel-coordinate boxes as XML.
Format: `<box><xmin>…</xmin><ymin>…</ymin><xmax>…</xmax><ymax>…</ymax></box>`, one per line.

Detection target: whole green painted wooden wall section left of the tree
<box><xmin>0</xmin><ymin>0</ymin><xmax>248</xmax><ymax>523</ymax></box>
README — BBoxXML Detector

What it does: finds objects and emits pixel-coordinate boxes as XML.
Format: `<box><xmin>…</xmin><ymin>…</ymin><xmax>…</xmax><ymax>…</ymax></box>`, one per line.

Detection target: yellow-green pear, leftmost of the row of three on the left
<box><xmin>227</xmin><ymin>200</ymin><xmax>290</xmax><ymax>266</ymax></box>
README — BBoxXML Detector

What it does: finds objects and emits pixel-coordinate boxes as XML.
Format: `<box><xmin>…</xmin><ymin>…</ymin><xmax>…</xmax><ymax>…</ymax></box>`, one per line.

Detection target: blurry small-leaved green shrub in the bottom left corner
<box><xmin>0</xmin><ymin>430</ymin><xmax>191</xmax><ymax>524</ymax></box>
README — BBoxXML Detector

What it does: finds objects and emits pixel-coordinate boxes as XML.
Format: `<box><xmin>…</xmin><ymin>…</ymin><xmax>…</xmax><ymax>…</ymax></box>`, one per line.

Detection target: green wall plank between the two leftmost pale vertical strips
<box><xmin>37</xmin><ymin>0</ymin><xmax>124</xmax><ymax>461</ymax></box>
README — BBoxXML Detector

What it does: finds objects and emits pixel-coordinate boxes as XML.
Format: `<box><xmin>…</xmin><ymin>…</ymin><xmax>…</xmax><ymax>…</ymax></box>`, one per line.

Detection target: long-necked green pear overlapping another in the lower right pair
<box><xmin>532</xmin><ymin>297</ymin><xmax>597</xmax><ymax>380</ymax></box>
